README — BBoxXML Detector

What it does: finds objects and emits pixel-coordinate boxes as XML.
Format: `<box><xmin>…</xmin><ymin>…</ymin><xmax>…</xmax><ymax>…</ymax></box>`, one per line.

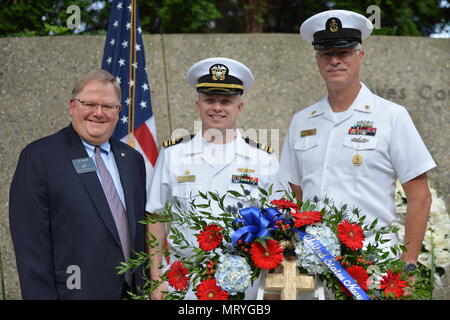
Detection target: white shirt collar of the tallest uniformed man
<box><xmin>308</xmin><ymin>82</ymin><xmax>375</xmax><ymax>121</ymax></box>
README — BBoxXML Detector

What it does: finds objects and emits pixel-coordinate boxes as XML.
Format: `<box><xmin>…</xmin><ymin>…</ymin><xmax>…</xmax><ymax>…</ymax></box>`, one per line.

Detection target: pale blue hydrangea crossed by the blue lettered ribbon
<box><xmin>295</xmin><ymin>225</ymin><xmax>341</xmax><ymax>274</ymax></box>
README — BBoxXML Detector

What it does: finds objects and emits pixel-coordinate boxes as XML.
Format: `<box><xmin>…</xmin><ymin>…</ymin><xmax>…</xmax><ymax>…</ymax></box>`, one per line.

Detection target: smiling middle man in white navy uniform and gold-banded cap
<box><xmin>146</xmin><ymin>57</ymin><xmax>278</xmax><ymax>300</ymax></box>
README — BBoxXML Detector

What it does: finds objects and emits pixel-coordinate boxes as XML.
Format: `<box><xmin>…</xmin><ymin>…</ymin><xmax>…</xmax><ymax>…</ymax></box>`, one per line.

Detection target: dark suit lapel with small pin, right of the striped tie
<box><xmin>109</xmin><ymin>139</ymin><xmax>136</xmax><ymax>248</ymax></box>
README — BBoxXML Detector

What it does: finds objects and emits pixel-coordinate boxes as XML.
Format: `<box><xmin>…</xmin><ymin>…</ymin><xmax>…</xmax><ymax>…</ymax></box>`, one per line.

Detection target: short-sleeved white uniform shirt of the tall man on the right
<box><xmin>279</xmin><ymin>83</ymin><xmax>436</xmax><ymax>231</ymax></box>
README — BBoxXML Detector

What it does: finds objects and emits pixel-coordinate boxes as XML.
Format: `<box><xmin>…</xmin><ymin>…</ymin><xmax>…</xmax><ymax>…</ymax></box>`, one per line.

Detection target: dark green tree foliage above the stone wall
<box><xmin>0</xmin><ymin>0</ymin><xmax>450</xmax><ymax>36</ymax></box>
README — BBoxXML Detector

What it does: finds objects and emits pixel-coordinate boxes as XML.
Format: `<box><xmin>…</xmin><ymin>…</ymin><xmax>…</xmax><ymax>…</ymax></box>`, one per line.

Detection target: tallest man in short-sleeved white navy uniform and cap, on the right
<box><xmin>279</xmin><ymin>10</ymin><xmax>436</xmax><ymax>278</ymax></box>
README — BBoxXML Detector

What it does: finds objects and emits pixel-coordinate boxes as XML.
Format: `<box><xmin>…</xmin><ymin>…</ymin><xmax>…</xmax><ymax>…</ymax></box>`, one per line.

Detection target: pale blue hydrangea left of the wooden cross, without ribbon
<box><xmin>216</xmin><ymin>254</ymin><xmax>252</xmax><ymax>295</ymax></box>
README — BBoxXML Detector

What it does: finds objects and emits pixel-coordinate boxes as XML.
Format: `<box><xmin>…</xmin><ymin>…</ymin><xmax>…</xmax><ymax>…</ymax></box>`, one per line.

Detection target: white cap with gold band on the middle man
<box><xmin>186</xmin><ymin>57</ymin><xmax>253</xmax><ymax>95</ymax></box>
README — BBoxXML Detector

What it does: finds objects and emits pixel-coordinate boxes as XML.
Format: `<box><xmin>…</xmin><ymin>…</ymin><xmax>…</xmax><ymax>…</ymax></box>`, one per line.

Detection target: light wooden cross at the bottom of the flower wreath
<box><xmin>265</xmin><ymin>259</ymin><xmax>315</xmax><ymax>300</ymax></box>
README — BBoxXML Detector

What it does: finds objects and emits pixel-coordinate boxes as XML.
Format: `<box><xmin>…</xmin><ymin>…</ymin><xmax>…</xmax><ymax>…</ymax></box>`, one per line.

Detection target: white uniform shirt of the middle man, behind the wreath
<box><xmin>146</xmin><ymin>131</ymin><xmax>278</xmax><ymax>256</ymax></box>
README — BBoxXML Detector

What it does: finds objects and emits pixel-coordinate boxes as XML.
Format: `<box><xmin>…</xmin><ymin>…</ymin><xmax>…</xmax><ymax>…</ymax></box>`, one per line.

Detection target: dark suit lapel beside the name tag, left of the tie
<box><xmin>65</xmin><ymin>126</ymin><xmax>122</xmax><ymax>248</ymax></box>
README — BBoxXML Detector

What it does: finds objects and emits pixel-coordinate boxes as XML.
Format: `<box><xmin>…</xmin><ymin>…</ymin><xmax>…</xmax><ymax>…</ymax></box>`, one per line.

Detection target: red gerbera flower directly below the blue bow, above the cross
<box><xmin>250</xmin><ymin>240</ymin><xmax>283</xmax><ymax>270</ymax></box>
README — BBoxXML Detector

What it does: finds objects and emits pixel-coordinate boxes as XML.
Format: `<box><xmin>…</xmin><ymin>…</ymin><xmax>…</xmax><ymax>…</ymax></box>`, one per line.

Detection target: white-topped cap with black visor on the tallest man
<box><xmin>300</xmin><ymin>10</ymin><xmax>373</xmax><ymax>50</ymax></box>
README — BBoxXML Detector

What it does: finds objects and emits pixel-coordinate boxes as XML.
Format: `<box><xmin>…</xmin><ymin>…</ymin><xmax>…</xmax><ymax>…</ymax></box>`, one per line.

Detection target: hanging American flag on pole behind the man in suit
<box><xmin>102</xmin><ymin>0</ymin><xmax>158</xmax><ymax>190</ymax></box>
